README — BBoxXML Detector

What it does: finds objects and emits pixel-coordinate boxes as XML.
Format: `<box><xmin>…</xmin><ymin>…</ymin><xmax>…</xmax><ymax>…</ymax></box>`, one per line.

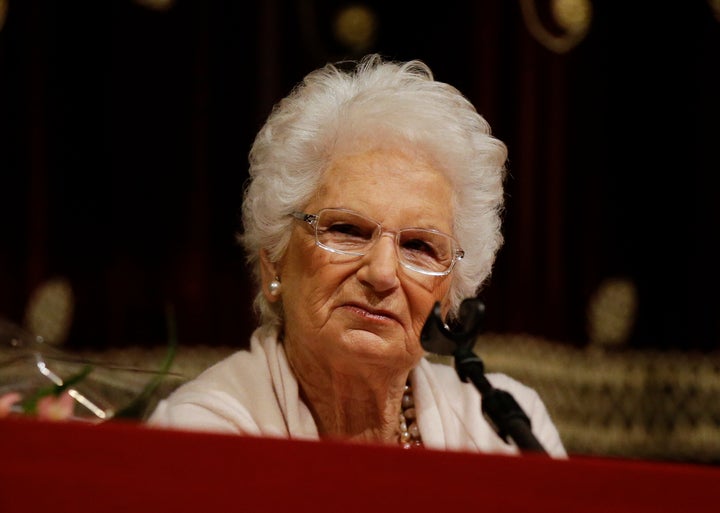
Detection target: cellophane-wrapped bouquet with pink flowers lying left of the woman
<box><xmin>0</xmin><ymin>310</ymin><xmax>185</xmax><ymax>423</ymax></box>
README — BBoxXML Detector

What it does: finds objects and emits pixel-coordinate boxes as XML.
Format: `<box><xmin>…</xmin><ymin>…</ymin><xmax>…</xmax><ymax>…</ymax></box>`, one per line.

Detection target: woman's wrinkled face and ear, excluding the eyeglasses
<box><xmin>264</xmin><ymin>150</ymin><xmax>453</xmax><ymax>374</ymax></box>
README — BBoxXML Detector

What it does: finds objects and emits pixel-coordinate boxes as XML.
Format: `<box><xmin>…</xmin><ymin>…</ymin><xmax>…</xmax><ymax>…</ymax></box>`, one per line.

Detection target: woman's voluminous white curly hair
<box><xmin>238</xmin><ymin>54</ymin><xmax>507</xmax><ymax>326</ymax></box>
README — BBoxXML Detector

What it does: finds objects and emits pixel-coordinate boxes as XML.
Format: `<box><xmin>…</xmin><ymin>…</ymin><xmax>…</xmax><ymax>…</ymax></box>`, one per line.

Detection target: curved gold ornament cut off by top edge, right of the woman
<box><xmin>520</xmin><ymin>0</ymin><xmax>593</xmax><ymax>53</ymax></box>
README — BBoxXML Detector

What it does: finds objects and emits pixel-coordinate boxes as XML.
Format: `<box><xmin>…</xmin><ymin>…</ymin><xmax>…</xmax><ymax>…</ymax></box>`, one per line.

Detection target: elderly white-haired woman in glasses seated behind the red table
<box><xmin>149</xmin><ymin>55</ymin><xmax>566</xmax><ymax>457</ymax></box>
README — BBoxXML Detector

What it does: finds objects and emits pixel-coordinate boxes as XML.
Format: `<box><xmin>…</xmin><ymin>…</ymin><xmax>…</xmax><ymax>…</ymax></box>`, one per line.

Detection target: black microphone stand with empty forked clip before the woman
<box><xmin>420</xmin><ymin>298</ymin><xmax>547</xmax><ymax>454</ymax></box>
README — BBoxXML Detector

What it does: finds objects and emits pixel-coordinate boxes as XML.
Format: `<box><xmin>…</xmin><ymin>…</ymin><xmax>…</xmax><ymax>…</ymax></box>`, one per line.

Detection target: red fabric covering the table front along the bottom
<box><xmin>0</xmin><ymin>418</ymin><xmax>720</xmax><ymax>513</ymax></box>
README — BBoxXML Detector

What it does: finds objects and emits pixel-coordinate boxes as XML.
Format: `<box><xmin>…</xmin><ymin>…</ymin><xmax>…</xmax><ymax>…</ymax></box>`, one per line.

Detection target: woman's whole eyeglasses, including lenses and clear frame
<box><xmin>290</xmin><ymin>208</ymin><xmax>465</xmax><ymax>276</ymax></box>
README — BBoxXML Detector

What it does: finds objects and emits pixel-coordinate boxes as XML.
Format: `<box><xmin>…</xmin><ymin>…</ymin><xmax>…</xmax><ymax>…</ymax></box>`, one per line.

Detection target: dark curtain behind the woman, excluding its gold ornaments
<box><xmin>0</xmin><ymin>0</ymin><xmax>720</xmax><ymax>351</ymax></box>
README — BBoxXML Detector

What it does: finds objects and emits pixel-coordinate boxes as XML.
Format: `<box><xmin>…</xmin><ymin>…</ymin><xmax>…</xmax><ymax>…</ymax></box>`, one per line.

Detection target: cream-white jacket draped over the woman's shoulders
<box><xmin>148</xmin><ymin>330</ymin><xmax>567</xmax><ymax>458</ymax></box>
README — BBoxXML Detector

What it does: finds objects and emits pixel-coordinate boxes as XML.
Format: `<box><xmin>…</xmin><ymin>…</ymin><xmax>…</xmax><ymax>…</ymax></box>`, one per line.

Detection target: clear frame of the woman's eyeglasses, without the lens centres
<box><xmin>290</xmin><ymin>208</ymin><xmax>465</xmax><ymax>276</ymax></box>
